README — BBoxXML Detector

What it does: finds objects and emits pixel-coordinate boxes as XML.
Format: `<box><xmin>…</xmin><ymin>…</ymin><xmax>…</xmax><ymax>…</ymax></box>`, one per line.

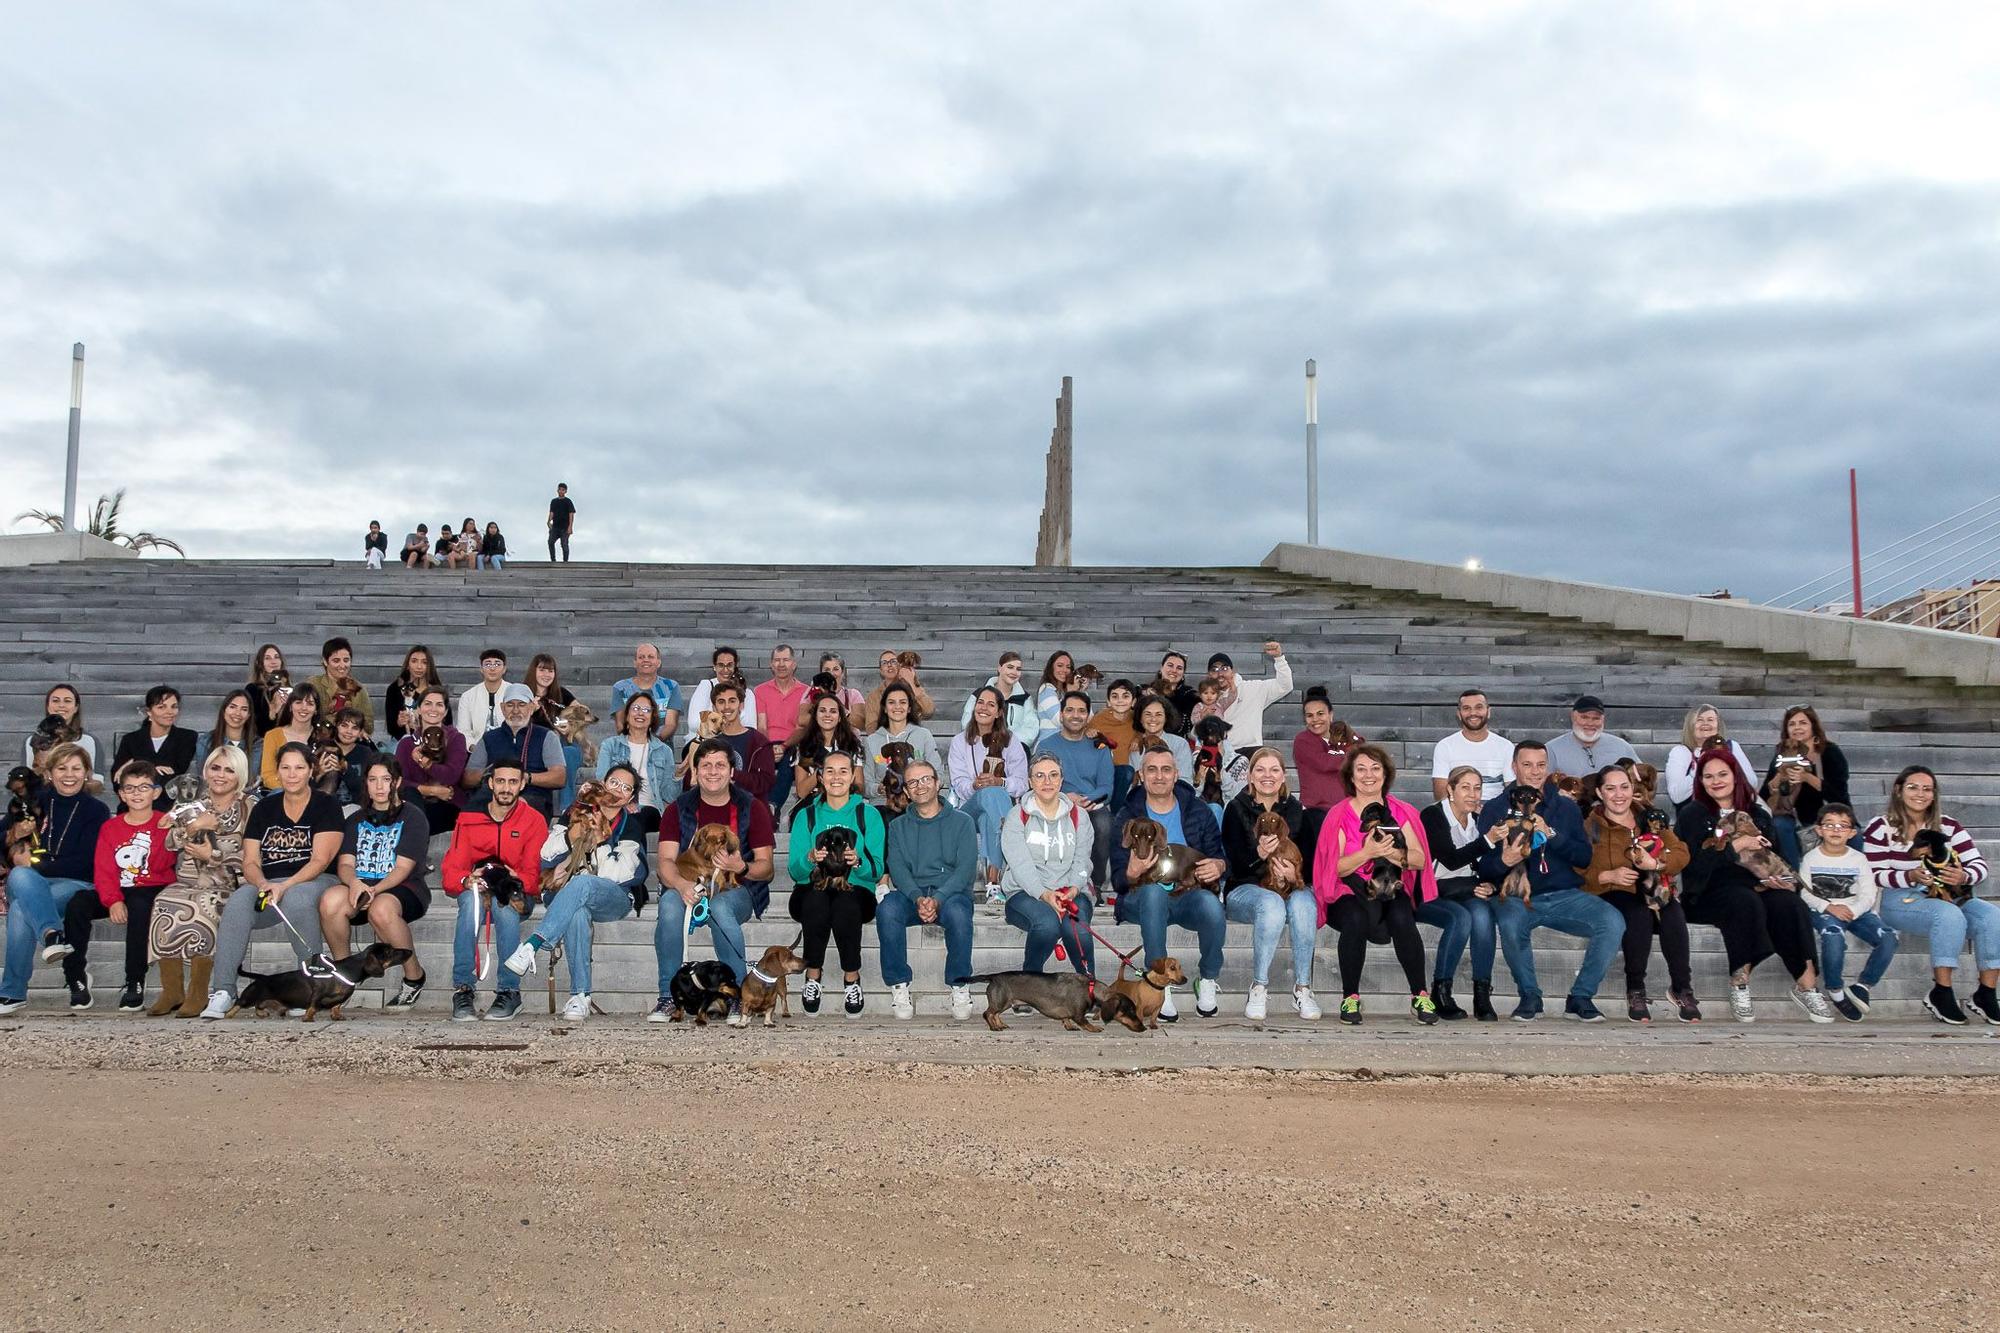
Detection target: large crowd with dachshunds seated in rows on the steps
<box><xmin>0</xmin><ymin>638</ymin><xmax>2000</xmax><ymax>1025</ymax></box>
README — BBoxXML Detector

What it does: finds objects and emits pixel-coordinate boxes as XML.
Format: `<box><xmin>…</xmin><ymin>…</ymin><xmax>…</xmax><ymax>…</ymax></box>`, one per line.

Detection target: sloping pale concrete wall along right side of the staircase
<box><xmin>1264</xmin><ymin>542</ymin><xmax>2000</xmax><ymax>687</ymax></box>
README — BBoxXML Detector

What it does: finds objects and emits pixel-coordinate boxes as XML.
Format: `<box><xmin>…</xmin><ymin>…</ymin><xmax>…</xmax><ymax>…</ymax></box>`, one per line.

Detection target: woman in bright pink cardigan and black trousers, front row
<box><xmin>1312</xmin><ymin>745</ymin><xmax>1438</xmax><ymax>1027</ymax></box>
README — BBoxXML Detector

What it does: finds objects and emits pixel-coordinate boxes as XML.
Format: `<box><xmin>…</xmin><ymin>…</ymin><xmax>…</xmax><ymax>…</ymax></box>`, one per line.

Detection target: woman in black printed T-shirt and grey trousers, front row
<box><xmin>202</xmin><ymin>740</ymin><xmax>346</xmax><ymax>1019</ymax></box>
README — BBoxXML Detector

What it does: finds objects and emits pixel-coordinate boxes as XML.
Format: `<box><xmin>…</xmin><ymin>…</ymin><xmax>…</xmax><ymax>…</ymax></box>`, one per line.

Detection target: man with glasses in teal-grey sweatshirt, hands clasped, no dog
<box><xmin>876</xmin><ymin>759</ymin><xmax>980</xmax><ymax>1021</ymax></box>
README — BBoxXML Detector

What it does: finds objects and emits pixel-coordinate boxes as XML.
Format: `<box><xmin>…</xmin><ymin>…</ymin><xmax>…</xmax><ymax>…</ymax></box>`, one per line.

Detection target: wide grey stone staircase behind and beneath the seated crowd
<box><xmin>0</xmin><ymin>560</ymin><xmax>2000</xmax><ymax>1017</ymax></box>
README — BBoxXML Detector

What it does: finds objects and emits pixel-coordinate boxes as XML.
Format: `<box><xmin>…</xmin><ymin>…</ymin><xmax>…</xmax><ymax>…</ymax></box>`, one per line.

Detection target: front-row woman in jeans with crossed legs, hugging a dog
<box><xmin>502</xmin><ymin>765</ymin><xmax>648</xmax><ymax>1023</ymax></box>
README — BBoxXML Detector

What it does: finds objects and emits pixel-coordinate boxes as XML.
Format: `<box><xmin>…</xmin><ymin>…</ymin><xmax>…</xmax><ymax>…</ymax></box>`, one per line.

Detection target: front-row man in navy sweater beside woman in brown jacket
<box><xmin>1478</xmin><ymin>741</ymin><xmax>1624</xmax><ymax>1023</ymax></box>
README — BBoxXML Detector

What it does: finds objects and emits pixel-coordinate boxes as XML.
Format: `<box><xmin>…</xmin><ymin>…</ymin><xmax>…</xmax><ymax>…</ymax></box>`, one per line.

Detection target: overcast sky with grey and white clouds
<box><xmin>0</xmin><ymin>0</ymin><xmax>2000</xmax><ymax>594</ymax></box>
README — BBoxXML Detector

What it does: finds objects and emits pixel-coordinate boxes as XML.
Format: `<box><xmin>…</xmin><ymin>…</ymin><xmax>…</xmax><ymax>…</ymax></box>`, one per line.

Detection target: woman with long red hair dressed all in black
<box><xmin>1674</xmin><ymin>747</ymin><xmax>1834</xmax><ymax>1023</ymax></box>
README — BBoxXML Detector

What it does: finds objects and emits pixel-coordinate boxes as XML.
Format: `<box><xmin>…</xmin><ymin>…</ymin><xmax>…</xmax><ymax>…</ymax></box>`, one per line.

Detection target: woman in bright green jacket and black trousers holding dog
<box><xmin>790</xmin><ymin>751</ymin><xmax>888</xmax><ymax>1015</ymax></box>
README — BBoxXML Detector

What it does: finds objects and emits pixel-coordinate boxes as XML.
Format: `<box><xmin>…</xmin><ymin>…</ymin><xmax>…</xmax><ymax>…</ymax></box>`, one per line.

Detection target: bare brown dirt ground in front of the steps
<box><xmin>0</xmin><ymin>1029</ymin><xmax>2000</xmax><ymax>1329</ymax></box>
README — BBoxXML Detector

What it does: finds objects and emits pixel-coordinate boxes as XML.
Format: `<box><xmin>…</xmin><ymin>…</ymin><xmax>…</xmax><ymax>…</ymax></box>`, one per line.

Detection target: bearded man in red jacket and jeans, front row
<box><xmin>440</xmin><ymin>757</ymin><xmax>548</xmax><ymax>1023</ymax></box>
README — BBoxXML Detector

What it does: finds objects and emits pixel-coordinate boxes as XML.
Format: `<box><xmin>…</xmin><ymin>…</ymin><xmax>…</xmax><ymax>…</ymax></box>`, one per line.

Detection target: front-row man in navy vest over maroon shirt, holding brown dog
<box><xmin>646</xmin><ymin>741</ymin><xmax>778</xmax><ymax>1025</ymax></box>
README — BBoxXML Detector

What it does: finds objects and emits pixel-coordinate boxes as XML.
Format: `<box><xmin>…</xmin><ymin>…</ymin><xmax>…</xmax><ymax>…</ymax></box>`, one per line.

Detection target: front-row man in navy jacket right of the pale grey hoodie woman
<box><xmin>1112</xmin><ymin>741</ymin><xmax>1230</xmax><ymax>1023</ymax></box>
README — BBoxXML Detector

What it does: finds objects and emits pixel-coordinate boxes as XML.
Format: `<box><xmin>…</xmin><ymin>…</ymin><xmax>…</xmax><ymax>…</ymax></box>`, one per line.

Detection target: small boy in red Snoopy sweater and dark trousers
<box><xmin>62</xmin><ymin>759</ymin><xmax>178</xmax><ymax>1013</ymax></box>
